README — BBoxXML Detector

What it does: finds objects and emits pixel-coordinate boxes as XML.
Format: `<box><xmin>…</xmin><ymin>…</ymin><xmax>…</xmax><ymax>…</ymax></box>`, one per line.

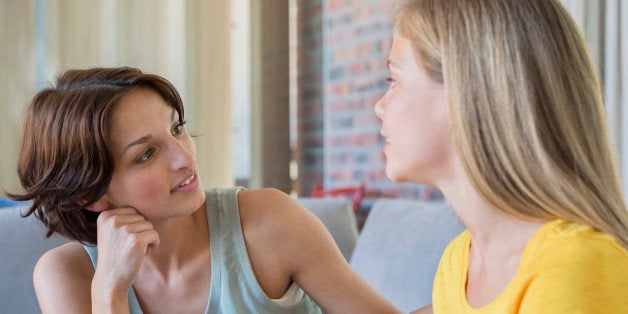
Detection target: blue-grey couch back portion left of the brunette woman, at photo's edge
<box><xmin>0</xmin><ymin>204</ymin><xmax>69</xmax><ymax>314</ymax></box>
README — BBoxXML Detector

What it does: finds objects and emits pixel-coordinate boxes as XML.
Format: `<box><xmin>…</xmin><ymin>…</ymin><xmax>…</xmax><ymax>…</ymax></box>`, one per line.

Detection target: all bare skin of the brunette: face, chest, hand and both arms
<box><xmin>34</xmin><ymin>88</ymin><xmax>398</xmax><ymax>313</ymax></box>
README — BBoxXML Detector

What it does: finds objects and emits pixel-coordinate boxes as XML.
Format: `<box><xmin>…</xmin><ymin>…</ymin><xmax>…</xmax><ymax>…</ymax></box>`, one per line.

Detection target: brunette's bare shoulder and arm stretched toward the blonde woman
<box><xmin>238</xmin><ymin>189</ymin><xmax>399</xmax><ymax>313</ymax></box>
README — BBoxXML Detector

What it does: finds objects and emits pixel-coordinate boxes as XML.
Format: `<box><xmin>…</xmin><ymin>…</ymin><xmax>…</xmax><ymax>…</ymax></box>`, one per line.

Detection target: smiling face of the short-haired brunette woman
<box><xmin>106</xmin><ymin>88</ymin><xmax>205</xmax><ymax>221</ymax></box>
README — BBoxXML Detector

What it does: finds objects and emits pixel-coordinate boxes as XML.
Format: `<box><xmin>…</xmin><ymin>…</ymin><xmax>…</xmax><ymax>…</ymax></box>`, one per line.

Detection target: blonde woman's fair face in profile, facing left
<box><xmin>375</xmin><ymin>33</ymin><xmax>454</xmax><ymax>185</ymax></box>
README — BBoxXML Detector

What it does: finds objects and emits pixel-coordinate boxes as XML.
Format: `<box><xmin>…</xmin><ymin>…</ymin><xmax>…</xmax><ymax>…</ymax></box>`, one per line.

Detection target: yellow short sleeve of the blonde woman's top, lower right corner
<box><xmin>519</xmin><ymin>234</ymin><xmax>628</xmax><ymax>313</ymax></box>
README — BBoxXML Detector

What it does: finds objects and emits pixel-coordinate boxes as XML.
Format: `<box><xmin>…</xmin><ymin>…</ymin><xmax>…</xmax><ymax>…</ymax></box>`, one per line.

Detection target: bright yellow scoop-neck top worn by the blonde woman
<box><xmin>432</xmin><ymin>220</ymin><xmax>628</xmax><ymax>314</ymax></box>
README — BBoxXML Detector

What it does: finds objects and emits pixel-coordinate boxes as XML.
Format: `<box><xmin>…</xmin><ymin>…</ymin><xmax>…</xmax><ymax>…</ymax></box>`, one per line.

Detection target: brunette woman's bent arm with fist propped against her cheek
<box><xmin>33</xmin><ymin>208</ymin><xmax>159</xmax><ymax>313</ymax></box>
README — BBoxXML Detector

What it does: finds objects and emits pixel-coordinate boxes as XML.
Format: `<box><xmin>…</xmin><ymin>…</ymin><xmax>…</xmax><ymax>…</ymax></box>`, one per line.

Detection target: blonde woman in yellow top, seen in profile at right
<box><xmin>375</xmin><ymin>0</ymin><xmax>628</xmax><ymax>313</ymax></box>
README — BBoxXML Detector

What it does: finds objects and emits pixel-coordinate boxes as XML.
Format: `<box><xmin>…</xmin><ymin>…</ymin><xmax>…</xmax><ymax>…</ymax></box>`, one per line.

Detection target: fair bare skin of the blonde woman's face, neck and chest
<box><xmin>375</xmin><ymin>33</ymin><xmax>544</xmax><ymax>313</ymax></box>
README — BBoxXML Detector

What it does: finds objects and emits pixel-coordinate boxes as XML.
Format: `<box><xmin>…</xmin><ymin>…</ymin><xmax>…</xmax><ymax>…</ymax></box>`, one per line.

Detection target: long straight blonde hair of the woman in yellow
<box><xmin>394</xmin><ymin>0</ymin><xmax>628</xmax><ymax>248</ymax></box>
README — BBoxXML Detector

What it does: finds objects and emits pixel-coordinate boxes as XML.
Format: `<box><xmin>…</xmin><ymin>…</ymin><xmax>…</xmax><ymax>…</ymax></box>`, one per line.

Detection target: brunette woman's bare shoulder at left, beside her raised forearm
<box><xmin>33</xmin><ymin>242</ymin><xmax>94</xmax><ymax>313</ymax></box>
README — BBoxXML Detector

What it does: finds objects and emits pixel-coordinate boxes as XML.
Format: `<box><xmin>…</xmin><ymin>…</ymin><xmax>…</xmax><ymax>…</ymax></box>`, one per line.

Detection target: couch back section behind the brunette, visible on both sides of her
<box><xmin>0</xmin><ymin>198</ymin><xmax>358</xmax><ymax>314</ymax></box>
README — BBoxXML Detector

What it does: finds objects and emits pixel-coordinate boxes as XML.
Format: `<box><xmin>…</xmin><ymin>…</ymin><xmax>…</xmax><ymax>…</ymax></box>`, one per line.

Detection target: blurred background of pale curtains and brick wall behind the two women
<box><xmin>0</xmin><ymin>0</ymin><xmax>628</xmax><ymax>207</ymax></box>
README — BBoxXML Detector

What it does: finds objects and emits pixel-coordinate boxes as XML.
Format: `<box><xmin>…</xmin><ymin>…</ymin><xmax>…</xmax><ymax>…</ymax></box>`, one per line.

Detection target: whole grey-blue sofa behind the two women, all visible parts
<box><xmin>0</xmin><ymin>198</ymin><xmax>464</xmax><ymax>314</ymax></box>
